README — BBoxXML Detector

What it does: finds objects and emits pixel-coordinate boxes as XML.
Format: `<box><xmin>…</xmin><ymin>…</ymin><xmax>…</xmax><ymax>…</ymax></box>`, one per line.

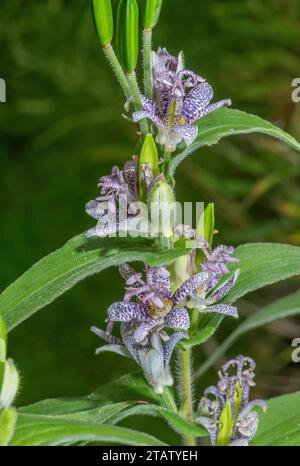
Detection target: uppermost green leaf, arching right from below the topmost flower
<box><xmin>169</xmin><ymin>107</ymin><xmax>300</xmax><ymax>176</ymax></box>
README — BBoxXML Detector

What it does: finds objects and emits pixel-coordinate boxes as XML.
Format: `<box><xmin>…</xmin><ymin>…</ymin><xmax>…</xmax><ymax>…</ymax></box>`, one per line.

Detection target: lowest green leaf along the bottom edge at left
<box><xmin>10</xmin><ymin>414</ymin><xmax>165</xmax><ymax>446</ymax></box>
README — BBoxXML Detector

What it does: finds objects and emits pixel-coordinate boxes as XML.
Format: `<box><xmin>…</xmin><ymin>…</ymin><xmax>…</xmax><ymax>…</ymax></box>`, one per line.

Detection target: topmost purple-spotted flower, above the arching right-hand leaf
<box><xmin>133</xmin><ymin>49</ymin><xmax>231</xmax><ymax>152</ymax></box>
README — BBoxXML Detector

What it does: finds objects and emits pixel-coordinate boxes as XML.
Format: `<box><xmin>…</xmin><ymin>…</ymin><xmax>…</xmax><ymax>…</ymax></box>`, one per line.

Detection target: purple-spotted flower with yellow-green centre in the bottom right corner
<box><xmin>197</xmin><ymin>356</ymin><xmax>266</xmax><ymax>446</ymax></box>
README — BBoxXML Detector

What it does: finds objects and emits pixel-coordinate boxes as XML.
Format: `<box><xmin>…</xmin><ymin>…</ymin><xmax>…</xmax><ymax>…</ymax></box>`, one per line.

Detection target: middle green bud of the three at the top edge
<box><xmin>116</xmin><ymin>0</ymin><xmax>139</xmax><ymax>73</ymax></box>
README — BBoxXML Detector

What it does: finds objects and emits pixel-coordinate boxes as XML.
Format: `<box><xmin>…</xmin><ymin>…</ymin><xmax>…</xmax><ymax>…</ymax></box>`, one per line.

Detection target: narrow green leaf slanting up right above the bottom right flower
<box><xmin>196</xmin><ymin>291</ymin><xmax>300</xmax><ymax>377</ymax></box>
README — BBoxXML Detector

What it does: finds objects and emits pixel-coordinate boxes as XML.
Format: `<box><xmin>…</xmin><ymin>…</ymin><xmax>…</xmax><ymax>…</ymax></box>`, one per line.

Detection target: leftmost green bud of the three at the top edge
<box><xmin>92</xmin><ymin>0</ymin><xmax>114</xmax><ymax>47</ymax></box>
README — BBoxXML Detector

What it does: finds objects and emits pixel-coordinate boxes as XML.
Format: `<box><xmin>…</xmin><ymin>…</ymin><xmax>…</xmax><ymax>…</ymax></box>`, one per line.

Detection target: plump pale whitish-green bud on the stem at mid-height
<box><xmin>148</xmin><ymin>175</ymin><xmax>176</xmax><ymax>238</ymax></box>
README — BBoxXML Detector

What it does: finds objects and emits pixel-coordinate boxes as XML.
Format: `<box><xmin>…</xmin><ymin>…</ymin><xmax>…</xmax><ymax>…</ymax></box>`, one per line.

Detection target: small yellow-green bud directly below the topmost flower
<box><xmin>139</xmin><ymin>133</ymin><xmax>158</xmax><ymax>202</ymax></box>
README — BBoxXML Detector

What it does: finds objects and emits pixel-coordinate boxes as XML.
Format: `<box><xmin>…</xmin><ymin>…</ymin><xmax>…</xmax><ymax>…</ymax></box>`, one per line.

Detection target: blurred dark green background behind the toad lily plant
<box><xmin>0</xmin><ymin>0</ymin><xmax>300</xmax><ymax>441</ymax></box>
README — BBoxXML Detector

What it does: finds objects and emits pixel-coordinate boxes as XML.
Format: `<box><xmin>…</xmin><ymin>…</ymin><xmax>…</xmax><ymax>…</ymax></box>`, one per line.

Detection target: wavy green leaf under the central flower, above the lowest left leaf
<box><xmin>14</xmin><ymin>374</ymin><xmax>207</xmax><ymax>444</ymax></box>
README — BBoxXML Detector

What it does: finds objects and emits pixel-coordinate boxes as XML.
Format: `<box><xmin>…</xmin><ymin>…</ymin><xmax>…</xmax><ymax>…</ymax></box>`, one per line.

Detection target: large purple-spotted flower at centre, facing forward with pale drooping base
<box><xmin>92</xmin><ymin>264</ymin><xmax>212</xmax><ymax>393</ymax></box>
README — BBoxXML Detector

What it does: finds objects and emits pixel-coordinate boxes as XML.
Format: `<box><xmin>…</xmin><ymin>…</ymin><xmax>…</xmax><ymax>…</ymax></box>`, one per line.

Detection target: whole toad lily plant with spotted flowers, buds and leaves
<box><xmin>0</xmin><ymin>0</ymin><xmax>300</xmax><ymax>446</ymax></box>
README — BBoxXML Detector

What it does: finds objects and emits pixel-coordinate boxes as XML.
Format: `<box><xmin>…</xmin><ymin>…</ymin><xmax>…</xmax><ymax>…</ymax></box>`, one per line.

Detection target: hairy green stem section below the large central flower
<box><xmin>179</xmin><ymin>348</ymin><xmax>196</xmax><ymax>446</ymax></box>
